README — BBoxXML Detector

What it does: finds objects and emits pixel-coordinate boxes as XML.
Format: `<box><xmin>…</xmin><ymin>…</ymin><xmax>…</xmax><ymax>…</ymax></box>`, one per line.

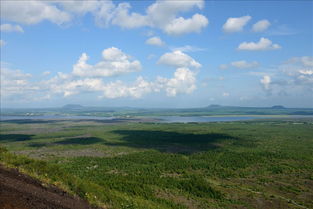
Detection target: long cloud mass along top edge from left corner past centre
<box><xmin>1</xmin><ymin>0</ymin><xmax>208</xmax><ymax>35</ymax></box>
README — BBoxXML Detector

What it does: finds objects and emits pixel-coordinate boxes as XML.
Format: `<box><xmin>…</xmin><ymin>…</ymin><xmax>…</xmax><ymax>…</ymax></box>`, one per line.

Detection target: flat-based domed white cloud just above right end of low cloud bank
<box><xmin>158</xmin><ymin>51</ymin><xmax>201</xmax><ymax>68</ymax></box>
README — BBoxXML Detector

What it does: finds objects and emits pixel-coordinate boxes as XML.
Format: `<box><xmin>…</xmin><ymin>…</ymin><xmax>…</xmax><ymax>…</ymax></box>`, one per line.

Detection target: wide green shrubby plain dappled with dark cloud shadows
<box><xmin>0</xmin><ymin>119</ymin><xmax>313</xmax><ymax>208</ymax></box>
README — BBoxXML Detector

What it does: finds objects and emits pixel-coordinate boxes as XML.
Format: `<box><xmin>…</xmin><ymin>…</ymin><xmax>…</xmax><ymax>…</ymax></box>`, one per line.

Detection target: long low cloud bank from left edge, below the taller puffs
<box><xmin>1</xmin><ymin>68</ymin><xmax>196</xmax><ymax>100</ymax></box>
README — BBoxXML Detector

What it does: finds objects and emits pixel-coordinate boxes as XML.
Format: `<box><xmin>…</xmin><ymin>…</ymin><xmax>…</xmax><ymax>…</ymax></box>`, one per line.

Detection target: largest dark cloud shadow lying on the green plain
<box><xmin>104</xmin><ymin>130</ymin><xmax>238</xmax><ymax>154</ymax></box>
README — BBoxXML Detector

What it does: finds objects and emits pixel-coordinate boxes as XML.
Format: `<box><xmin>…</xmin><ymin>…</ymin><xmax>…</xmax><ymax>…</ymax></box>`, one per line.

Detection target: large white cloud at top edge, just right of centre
<box><xmin>104</xmin><ymin>0</ymin><xmax>208</xmax><ymax>35</ymax></box>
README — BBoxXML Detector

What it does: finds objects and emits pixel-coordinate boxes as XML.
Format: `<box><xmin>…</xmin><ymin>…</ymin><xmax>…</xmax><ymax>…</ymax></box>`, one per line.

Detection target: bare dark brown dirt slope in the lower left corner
<box><xmin>0</xmin><ymin>165</ymin><xmax>100</xmax><ymax>209</ymax></box>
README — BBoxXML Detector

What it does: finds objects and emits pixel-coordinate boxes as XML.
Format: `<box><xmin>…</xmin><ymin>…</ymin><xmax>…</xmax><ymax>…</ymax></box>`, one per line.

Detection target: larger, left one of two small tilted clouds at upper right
<box><xmin>223</xmin><ymin>15</ymin><xmax>251</xmax><ymax>33</ymax></box>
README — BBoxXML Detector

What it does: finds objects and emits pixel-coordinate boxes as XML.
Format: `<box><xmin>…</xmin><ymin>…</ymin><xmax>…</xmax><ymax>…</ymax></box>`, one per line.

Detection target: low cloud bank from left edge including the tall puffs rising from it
<box><xmin>1</xmin><ymin>47</ymin><xmax>199</xmax><ymax>100</ymax></box>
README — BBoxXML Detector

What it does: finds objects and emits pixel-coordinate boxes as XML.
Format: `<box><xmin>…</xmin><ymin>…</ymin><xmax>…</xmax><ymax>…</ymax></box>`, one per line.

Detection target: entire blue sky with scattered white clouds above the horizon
<box><xmin>0</xmin><ymin>0</ymin><xmax>313</xmax><ymax>107</ymax></box>
